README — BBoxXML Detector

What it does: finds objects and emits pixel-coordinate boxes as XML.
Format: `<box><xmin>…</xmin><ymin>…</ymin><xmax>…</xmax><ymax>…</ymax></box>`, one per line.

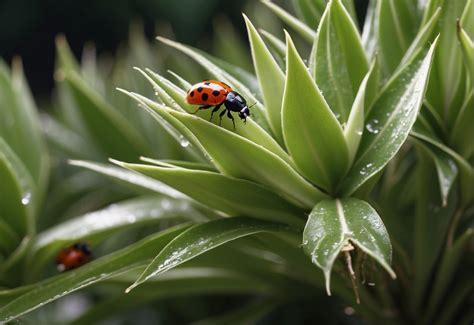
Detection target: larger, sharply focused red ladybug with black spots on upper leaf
<box><xmin>186</xmin><ymin>79</ymin><xmax>250</xmax><ymax>130</ymax></box>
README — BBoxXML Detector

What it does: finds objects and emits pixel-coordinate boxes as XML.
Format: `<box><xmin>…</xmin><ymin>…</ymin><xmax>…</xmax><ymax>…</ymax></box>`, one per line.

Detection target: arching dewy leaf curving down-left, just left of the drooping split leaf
<box><xmin>126</xmin><ymin>217</ymin><xmax>296</xmax><ymax>292</ymax></box>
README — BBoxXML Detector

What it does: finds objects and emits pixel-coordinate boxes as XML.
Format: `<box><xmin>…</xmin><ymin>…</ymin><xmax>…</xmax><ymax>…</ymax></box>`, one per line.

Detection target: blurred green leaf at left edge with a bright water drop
<box><xmin>0</xmin><ymin>137</ymin><xmax>38</xmax><ymax>236</ymax></box>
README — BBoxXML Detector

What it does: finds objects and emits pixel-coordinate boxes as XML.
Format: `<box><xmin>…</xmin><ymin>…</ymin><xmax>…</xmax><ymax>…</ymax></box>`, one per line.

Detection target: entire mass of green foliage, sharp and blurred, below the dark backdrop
<box><xmin>0</xmin><ymin>0</ymin><xmax>474</xmax><ymax>324</ymax></box>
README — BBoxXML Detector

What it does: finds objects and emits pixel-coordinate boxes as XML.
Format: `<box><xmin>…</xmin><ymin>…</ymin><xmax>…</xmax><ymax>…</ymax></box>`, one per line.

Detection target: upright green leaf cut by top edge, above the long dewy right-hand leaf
<box><xmin>377</xmin><ymin>0</ymin><xmax>417</xmax><ymax>76</ymax></box>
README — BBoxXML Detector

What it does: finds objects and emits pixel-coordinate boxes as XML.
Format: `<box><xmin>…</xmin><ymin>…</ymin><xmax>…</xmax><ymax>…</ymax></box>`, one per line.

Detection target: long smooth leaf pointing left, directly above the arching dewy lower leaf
<box><xmin>115</xmin><ymin>161</ymin><xmax>303</xmax><ymax>227</ymax></box>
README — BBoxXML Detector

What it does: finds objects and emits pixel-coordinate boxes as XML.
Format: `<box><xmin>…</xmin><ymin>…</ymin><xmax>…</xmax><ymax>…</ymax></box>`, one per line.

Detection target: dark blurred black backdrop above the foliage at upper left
<box><xmin>0</xmin><ymin>0</ymin><xmax>367</xmax><ymax>98</ymax></box>
